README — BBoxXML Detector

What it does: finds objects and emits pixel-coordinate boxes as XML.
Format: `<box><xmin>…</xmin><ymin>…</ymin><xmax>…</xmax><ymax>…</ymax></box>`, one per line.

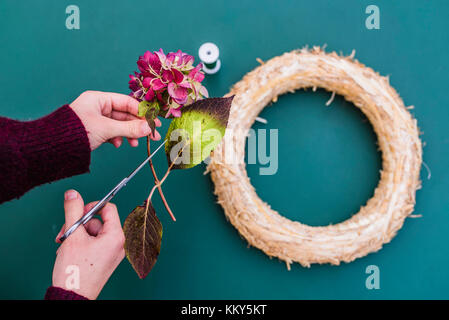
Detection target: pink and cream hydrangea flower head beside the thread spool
<box><xmin>129</xmin><ymin>49</ymin><xmax>209</xmax><ymax>118</ymax></box>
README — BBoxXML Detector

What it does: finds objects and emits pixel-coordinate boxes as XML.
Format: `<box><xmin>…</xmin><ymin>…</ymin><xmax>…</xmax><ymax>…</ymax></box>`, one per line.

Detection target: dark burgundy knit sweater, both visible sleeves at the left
<box><xmin>0</xmin><ymin>105</ymin><xmax>90</xmax><ymax>300</ymax></box>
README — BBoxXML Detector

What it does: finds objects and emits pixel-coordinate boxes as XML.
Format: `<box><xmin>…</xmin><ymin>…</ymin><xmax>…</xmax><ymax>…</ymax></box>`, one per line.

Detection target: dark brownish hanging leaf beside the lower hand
<box><xmin>123</xmin><ymin>202</ymin><xmax>162</xmax><ymax>279</ymax></box>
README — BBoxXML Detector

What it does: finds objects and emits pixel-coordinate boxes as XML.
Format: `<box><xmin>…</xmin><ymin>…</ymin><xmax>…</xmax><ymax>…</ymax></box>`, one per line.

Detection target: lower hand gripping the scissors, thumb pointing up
<box><xmin>52</xmin><ymin>190</ymin><xmax>125</xmax><ymax>300</ymax></box>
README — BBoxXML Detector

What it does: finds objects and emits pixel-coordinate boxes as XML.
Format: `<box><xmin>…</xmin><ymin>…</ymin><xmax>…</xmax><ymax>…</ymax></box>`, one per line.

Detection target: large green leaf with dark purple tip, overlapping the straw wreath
<box><xmin>165</xmin><ymin>96</ymin><xmax>234</xmax><ymax>169</ymax></box>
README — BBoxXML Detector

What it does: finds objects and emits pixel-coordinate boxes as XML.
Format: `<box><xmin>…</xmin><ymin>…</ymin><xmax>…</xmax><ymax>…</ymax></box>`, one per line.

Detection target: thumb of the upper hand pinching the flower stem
<box><xmin>105</xmin><ymin>119</ymin><xmax>151</xmax><ymax>139</ymax></box>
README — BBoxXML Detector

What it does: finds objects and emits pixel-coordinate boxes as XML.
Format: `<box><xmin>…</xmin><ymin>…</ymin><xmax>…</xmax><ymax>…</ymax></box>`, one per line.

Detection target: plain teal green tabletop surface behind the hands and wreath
<box><xmin>0</xmin><ymin>0</ymin><xmax>449</xmax><ymax>299</ymax></box>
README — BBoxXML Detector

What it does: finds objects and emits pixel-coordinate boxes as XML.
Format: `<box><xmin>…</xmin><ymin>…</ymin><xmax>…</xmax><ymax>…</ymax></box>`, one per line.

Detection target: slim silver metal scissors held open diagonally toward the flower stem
<box><xmin>59</xmin><ymin>140</ymin><xmax>167</xmax><ymax>243</ymax></box>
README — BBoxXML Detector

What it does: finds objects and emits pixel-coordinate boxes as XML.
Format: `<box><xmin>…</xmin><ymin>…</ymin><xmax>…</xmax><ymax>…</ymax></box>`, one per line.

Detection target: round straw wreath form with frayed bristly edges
<box><xmin>208</xmin><ymin>47</ymin><xmax>422</xmax><ymax>269</ymax></box>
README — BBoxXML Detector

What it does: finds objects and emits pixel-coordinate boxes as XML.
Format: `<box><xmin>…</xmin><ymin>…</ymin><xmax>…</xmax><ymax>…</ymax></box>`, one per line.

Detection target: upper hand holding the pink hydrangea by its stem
<box><xmin>70</xmin><ymin>91</ymin><xmax>161</xmax><ymax>150</ymax></box>
